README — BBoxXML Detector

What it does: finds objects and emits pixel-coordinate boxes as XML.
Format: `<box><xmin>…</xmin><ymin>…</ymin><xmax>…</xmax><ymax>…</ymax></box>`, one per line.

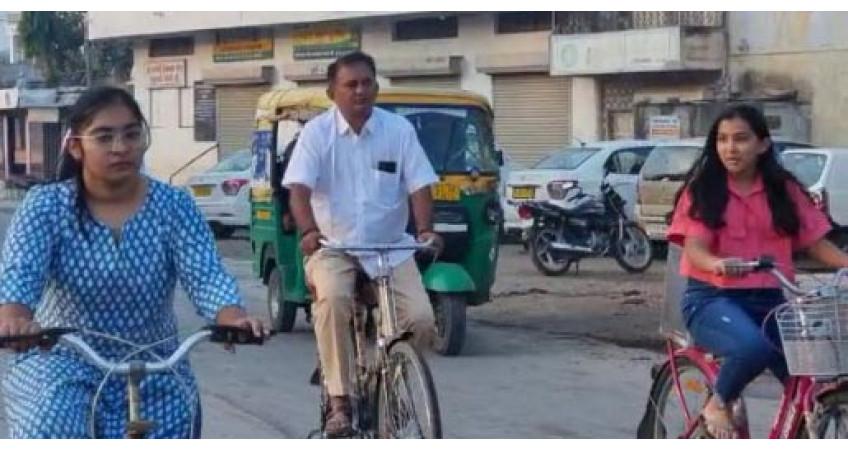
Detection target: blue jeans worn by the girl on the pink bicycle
<box><xmin>681</xmin><ymin>278</ymin><xmax>789</xmax><ymax>402</ymax></box>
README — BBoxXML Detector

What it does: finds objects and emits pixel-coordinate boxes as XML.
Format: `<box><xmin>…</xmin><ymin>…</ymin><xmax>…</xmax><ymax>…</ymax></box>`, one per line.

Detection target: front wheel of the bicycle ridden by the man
<box><xmin>377</xmin><ymin>341</ymin><xmax>442</xmax><ymax>439</ymax></box>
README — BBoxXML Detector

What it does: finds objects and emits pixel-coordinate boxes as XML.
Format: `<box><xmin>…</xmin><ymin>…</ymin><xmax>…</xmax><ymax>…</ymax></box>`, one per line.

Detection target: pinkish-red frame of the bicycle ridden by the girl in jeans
<box><xmin>664</xmin><ymin>338</ymin><xmax>835</xmax><ymax>439</ymax></box>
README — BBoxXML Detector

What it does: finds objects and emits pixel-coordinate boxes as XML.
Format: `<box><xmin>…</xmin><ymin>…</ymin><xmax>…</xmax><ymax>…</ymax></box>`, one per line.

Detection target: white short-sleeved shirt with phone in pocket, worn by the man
<box><xmin>283</xmin><ymin>107</ymin><xmax>439</xmax><ymax>276</ymax></box>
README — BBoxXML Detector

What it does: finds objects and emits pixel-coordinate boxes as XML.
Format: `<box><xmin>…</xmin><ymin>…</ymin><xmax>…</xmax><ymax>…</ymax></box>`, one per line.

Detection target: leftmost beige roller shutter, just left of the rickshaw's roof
<box><xmin>215</xmin><ymin>86</ymin><xmax>269</xmax><ymax>157</ymax></box>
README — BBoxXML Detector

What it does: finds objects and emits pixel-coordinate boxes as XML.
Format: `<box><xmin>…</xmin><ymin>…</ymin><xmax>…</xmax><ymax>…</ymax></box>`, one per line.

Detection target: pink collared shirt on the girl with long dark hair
<box><xmin>667</xmin><ymin>177</ymin><xmax>830</xmax><ymax>288</ymax></box>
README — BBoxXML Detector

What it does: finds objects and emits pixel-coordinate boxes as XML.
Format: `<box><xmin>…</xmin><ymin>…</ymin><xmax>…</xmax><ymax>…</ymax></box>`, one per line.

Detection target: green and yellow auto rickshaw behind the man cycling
<box><xmin>250</xmin><ymin>88</ymin><xmax>503</xmax><ymax>355</ymax></box>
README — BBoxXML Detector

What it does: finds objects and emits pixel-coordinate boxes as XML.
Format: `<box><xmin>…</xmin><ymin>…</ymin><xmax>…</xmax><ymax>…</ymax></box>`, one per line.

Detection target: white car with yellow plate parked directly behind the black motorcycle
<box><xmin>504</xmin><ymin>140</ymin><xmax>656</xmax><ymax>234</ymax></box>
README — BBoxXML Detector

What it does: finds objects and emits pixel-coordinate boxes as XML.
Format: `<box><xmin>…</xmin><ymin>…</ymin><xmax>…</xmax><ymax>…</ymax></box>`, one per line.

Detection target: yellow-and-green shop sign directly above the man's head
<box><xmin>292</xmin><ymin>24</ymin><xmax>360</xmax><ymax>60</ymax></box>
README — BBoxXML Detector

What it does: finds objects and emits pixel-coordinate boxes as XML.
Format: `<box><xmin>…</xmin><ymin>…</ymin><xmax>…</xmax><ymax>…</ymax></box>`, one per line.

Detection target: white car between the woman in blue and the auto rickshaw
<box><xmin>186</xmin><ymin>150</ymin><xmax>253</xmax><ymax>238</ymax></box>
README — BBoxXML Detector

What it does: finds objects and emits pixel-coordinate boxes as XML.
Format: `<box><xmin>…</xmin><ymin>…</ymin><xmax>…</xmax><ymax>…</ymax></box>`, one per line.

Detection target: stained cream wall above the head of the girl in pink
<box><xmin>728</xmin><ymin>12</ymin><xmax>848</xmax><ymax>146</ymax></box>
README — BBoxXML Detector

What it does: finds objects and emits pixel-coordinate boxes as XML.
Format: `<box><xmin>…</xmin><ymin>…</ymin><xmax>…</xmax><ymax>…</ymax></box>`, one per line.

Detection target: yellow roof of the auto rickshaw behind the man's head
<box><xmin>256</xmin><ymin>88</ymin><xmax>492</xmax><ymax>118</ymax></box>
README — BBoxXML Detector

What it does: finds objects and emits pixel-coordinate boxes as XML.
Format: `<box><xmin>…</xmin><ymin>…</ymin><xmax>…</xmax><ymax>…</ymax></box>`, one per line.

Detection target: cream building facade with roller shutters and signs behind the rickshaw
<box><xmin>88</xmin><ymin>12</ymin><xmax>727</xmax><ymax>182</ymax></box>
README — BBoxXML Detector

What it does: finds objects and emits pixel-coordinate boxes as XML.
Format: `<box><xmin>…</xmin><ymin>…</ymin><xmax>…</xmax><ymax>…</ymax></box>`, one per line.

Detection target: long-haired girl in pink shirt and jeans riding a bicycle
<box><xmin>668</xmin><ymin>105</ymin><xmax>848</xmax><ymax>438</ymax></box>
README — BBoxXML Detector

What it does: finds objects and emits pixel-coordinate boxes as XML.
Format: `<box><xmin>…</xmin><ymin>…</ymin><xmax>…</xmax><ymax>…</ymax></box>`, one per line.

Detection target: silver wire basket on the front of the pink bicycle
<box><xmin>776</xmin><ymin>296</ymin><xmax>848</xmax><ymax>376</ymax></box>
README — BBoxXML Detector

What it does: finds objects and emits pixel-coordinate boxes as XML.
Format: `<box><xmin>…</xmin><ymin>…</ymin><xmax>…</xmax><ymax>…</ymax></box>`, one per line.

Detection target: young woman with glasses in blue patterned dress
<box><xmin>0</xmin><ymin>87</ymin><xmax>265</xmax><ymax>438</ymax></box>
